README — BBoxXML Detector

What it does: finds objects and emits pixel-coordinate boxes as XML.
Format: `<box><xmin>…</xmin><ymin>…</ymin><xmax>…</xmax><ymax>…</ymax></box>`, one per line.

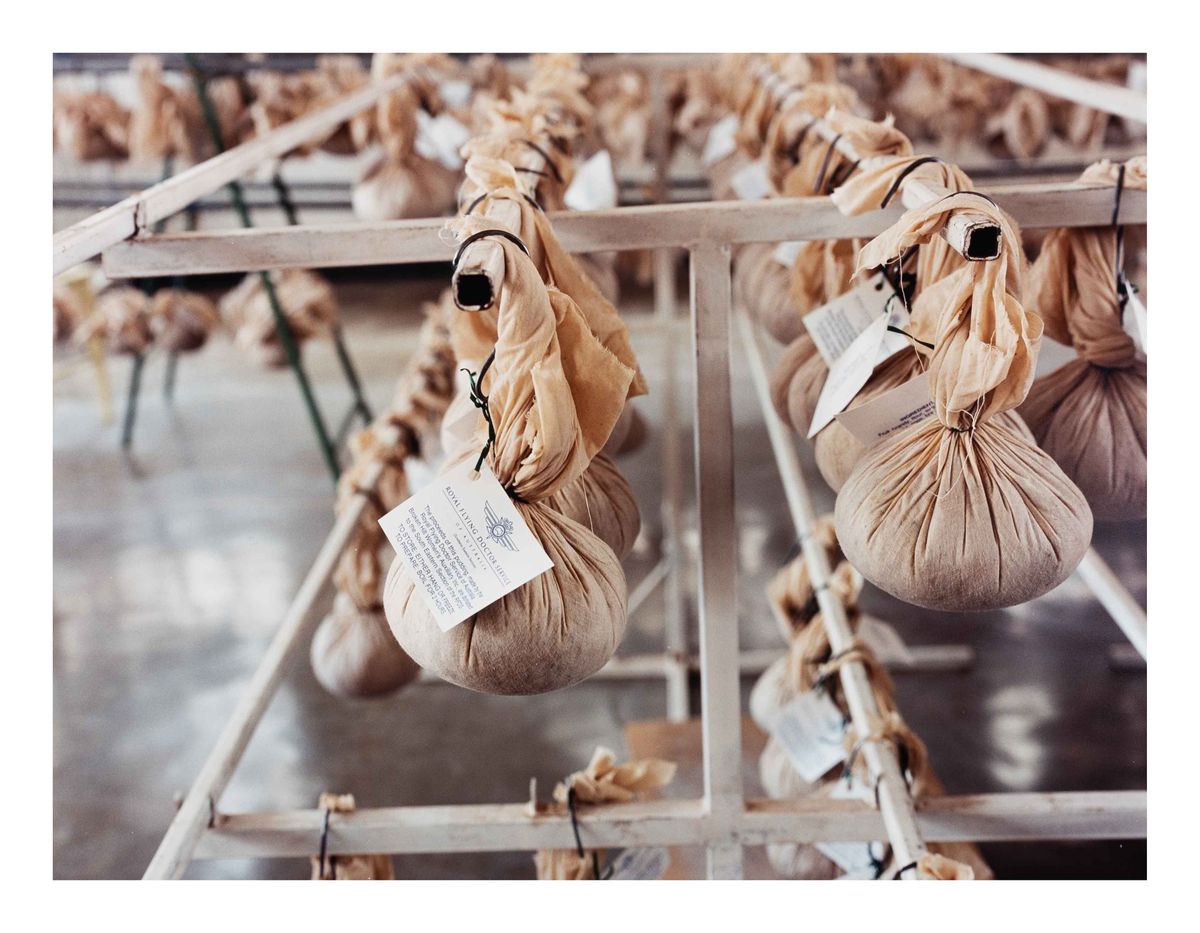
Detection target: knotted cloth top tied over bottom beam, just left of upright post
<box><xmin>534</xmin><ymin>747</ymin><xmax>676</xmax><ymax>881</ymax></box>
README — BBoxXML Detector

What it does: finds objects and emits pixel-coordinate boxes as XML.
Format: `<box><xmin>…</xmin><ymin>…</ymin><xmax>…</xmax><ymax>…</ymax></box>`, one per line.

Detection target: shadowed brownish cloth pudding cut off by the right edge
<box><xmin>1019</xmin><ymin>156</ymin><xmax>1146</xmax><ymax>520</ymax></box>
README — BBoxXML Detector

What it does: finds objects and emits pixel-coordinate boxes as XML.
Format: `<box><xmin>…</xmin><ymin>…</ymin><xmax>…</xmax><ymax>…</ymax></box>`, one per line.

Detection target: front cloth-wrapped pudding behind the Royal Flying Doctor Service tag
<box><xmin>384</xmin><ymin>236</ymin><xmax>636</xmax><ymax>694</ymax></box>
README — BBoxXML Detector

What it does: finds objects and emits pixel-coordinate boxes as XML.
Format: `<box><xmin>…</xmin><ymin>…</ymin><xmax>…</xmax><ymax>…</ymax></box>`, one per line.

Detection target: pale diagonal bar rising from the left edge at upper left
<box><xmin>54</xmin><ymin>74</ymin><xmax>408</xmax><ymax>275</ymax></box>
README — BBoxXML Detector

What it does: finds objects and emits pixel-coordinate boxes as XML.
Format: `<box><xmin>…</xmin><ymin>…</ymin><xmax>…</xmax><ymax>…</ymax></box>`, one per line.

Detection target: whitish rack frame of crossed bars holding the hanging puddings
<box><xmin>54</xmin><ymin>50</ymin><xmax>1146</xmax><ymax>878</ymax></box>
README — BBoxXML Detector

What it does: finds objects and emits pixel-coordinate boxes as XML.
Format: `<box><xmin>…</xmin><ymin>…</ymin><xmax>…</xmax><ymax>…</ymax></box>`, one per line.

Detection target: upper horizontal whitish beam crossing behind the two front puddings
<box><xmin>104</xmin><ymin>182</ymin><xmax>1146</xmax><ymax>278</ymax></box>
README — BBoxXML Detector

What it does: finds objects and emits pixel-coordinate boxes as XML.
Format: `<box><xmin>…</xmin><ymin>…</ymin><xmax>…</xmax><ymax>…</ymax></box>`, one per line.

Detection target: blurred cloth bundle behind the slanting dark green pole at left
<box><xmin>218</xmin><ymin>269</ymin><xmax>338</xmax><ymax>368</ymax></box>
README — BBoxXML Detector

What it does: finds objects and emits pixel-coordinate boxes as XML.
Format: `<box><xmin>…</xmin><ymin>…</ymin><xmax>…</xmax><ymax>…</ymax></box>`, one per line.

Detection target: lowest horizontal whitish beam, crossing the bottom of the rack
<box><xmin>196</xmin><ymin>790</ymin><xmax>1146</xmax><ymax>859</ymax></box>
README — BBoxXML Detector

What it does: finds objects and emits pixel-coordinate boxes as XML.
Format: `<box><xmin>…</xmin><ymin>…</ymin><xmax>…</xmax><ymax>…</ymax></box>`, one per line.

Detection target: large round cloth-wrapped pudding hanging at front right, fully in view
<box><xmin>835</xmin><ymin>192</ymin><xmax>1092</xmax><ymax>610</ymax></box>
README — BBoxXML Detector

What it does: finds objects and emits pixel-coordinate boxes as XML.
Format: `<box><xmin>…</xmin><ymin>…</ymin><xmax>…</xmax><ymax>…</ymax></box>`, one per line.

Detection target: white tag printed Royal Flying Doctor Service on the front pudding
<box><xmin>379</xmin><ymin>463</ymin><xmax>554</xmax><ymax>632</ymax></box>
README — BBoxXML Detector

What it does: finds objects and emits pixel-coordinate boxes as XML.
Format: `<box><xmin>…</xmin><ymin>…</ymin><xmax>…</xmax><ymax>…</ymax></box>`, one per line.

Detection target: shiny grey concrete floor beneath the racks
<box><xmin>54</xmin><ymin>265</ymin><xmax>1146</xmax><ymax>878</ymax></box>
